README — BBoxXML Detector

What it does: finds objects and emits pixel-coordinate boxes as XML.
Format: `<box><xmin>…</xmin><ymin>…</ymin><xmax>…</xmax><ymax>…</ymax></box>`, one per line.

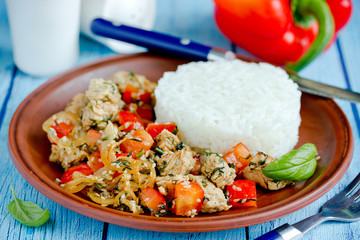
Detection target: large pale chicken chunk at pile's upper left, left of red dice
<box><xmin>82</xmin><ymin>79</ymin><xmax>124</xmax><ymax>130</ymax></box>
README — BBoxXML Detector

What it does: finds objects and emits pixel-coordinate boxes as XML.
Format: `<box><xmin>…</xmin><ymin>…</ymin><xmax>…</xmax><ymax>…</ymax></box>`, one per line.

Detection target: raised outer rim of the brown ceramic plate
<box><xmin>8</xmin><ymin>53</ymin><xmax>354</xmax><ymax>232</ymax></box>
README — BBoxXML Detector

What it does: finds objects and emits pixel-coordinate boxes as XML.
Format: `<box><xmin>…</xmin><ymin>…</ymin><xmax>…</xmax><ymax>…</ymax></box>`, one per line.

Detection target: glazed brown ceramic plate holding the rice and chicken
<box><xmin>9</xmin><ymin>54</ymin><xmax>353</xmax><ymax>232</ymax></box>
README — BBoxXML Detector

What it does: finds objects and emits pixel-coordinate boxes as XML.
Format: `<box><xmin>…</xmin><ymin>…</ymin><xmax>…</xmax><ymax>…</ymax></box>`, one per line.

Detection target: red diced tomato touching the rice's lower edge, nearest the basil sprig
<box><xmin>223</xmin><ymin>143</ymin><xmax>252</xmax><ymax>174</ymax></box>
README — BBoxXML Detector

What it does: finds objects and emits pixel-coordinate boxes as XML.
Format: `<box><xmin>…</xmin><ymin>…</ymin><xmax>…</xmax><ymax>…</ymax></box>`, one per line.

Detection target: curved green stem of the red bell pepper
<box><xmin>285</xmin><ymin>0</ymin><xmax>335</xmax><ymax>72</ymax></box>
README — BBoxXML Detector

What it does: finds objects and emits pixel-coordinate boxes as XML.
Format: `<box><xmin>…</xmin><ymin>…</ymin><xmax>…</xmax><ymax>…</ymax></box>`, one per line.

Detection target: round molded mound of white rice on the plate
<box><xmin>155</xmin><ymin>60</ymin><xmax>301</xmax><ymax>158</ymax></box>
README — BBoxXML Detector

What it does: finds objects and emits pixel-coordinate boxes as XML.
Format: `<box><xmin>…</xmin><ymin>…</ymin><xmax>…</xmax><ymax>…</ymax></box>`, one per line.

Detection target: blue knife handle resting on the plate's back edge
<box><xmin>91</xmin><ymin>18</ymin><xmax>212</xmax><ymax>61</ymax></box>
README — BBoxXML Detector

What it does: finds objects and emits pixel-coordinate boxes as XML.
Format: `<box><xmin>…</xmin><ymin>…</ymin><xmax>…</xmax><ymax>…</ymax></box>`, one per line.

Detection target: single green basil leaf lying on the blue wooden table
<box><xmin>8</xmin><ymin>186</ymin><xmax>50</xmax><ymax>227</ymax></box>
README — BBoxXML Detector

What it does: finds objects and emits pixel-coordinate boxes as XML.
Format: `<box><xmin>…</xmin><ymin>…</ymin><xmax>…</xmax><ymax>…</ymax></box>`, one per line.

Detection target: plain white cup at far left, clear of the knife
<box><xmin>6</xmin><ymin>0</ymin><xmax>80</xmax><ymax>76</ymax></box>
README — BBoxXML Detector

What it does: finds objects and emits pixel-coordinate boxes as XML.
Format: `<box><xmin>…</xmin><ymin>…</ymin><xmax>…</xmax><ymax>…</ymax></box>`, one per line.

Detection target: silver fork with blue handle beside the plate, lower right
<box><xmin>257</xmin><ymin>173</ymin><xmax>360</xmax><ymax>240</ymax></box>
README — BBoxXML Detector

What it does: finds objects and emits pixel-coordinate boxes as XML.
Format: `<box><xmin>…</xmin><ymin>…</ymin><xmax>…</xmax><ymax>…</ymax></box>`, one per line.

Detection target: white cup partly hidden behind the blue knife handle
<box><xmin>80</xmin><ymin>0</ymin><xmax>156</xmax><ymax>53</ymax></box>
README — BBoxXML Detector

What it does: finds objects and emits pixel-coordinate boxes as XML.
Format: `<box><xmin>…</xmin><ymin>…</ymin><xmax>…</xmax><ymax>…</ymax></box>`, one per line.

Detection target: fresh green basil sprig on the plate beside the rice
<box><xmin>262</xmin><ymin>143</ymin><xmax>317</xmax><ymax>181</ymax></box>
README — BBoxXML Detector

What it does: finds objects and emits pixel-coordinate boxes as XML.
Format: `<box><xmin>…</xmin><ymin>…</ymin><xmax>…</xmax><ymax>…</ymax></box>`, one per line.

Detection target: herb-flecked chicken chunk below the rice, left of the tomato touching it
<box><xmin>201</xmin><ymin>153</ymin><xmax>236</xmax><ymax>189</ymax></box>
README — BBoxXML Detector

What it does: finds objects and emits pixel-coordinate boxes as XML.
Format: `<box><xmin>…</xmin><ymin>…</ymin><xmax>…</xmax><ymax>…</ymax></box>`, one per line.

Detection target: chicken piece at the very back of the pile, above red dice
<box><xmin>110</xmin><ymin>71</ymin><xmax>156</xmax><ymax>93</ymax></box>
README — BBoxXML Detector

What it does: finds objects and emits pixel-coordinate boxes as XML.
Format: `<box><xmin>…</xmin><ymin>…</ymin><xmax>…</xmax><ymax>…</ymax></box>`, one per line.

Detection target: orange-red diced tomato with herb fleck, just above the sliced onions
<box><xmin>120</xmin><ymin>129</ymin><xmax>154</xmax><ymax>157</ymax></box>
